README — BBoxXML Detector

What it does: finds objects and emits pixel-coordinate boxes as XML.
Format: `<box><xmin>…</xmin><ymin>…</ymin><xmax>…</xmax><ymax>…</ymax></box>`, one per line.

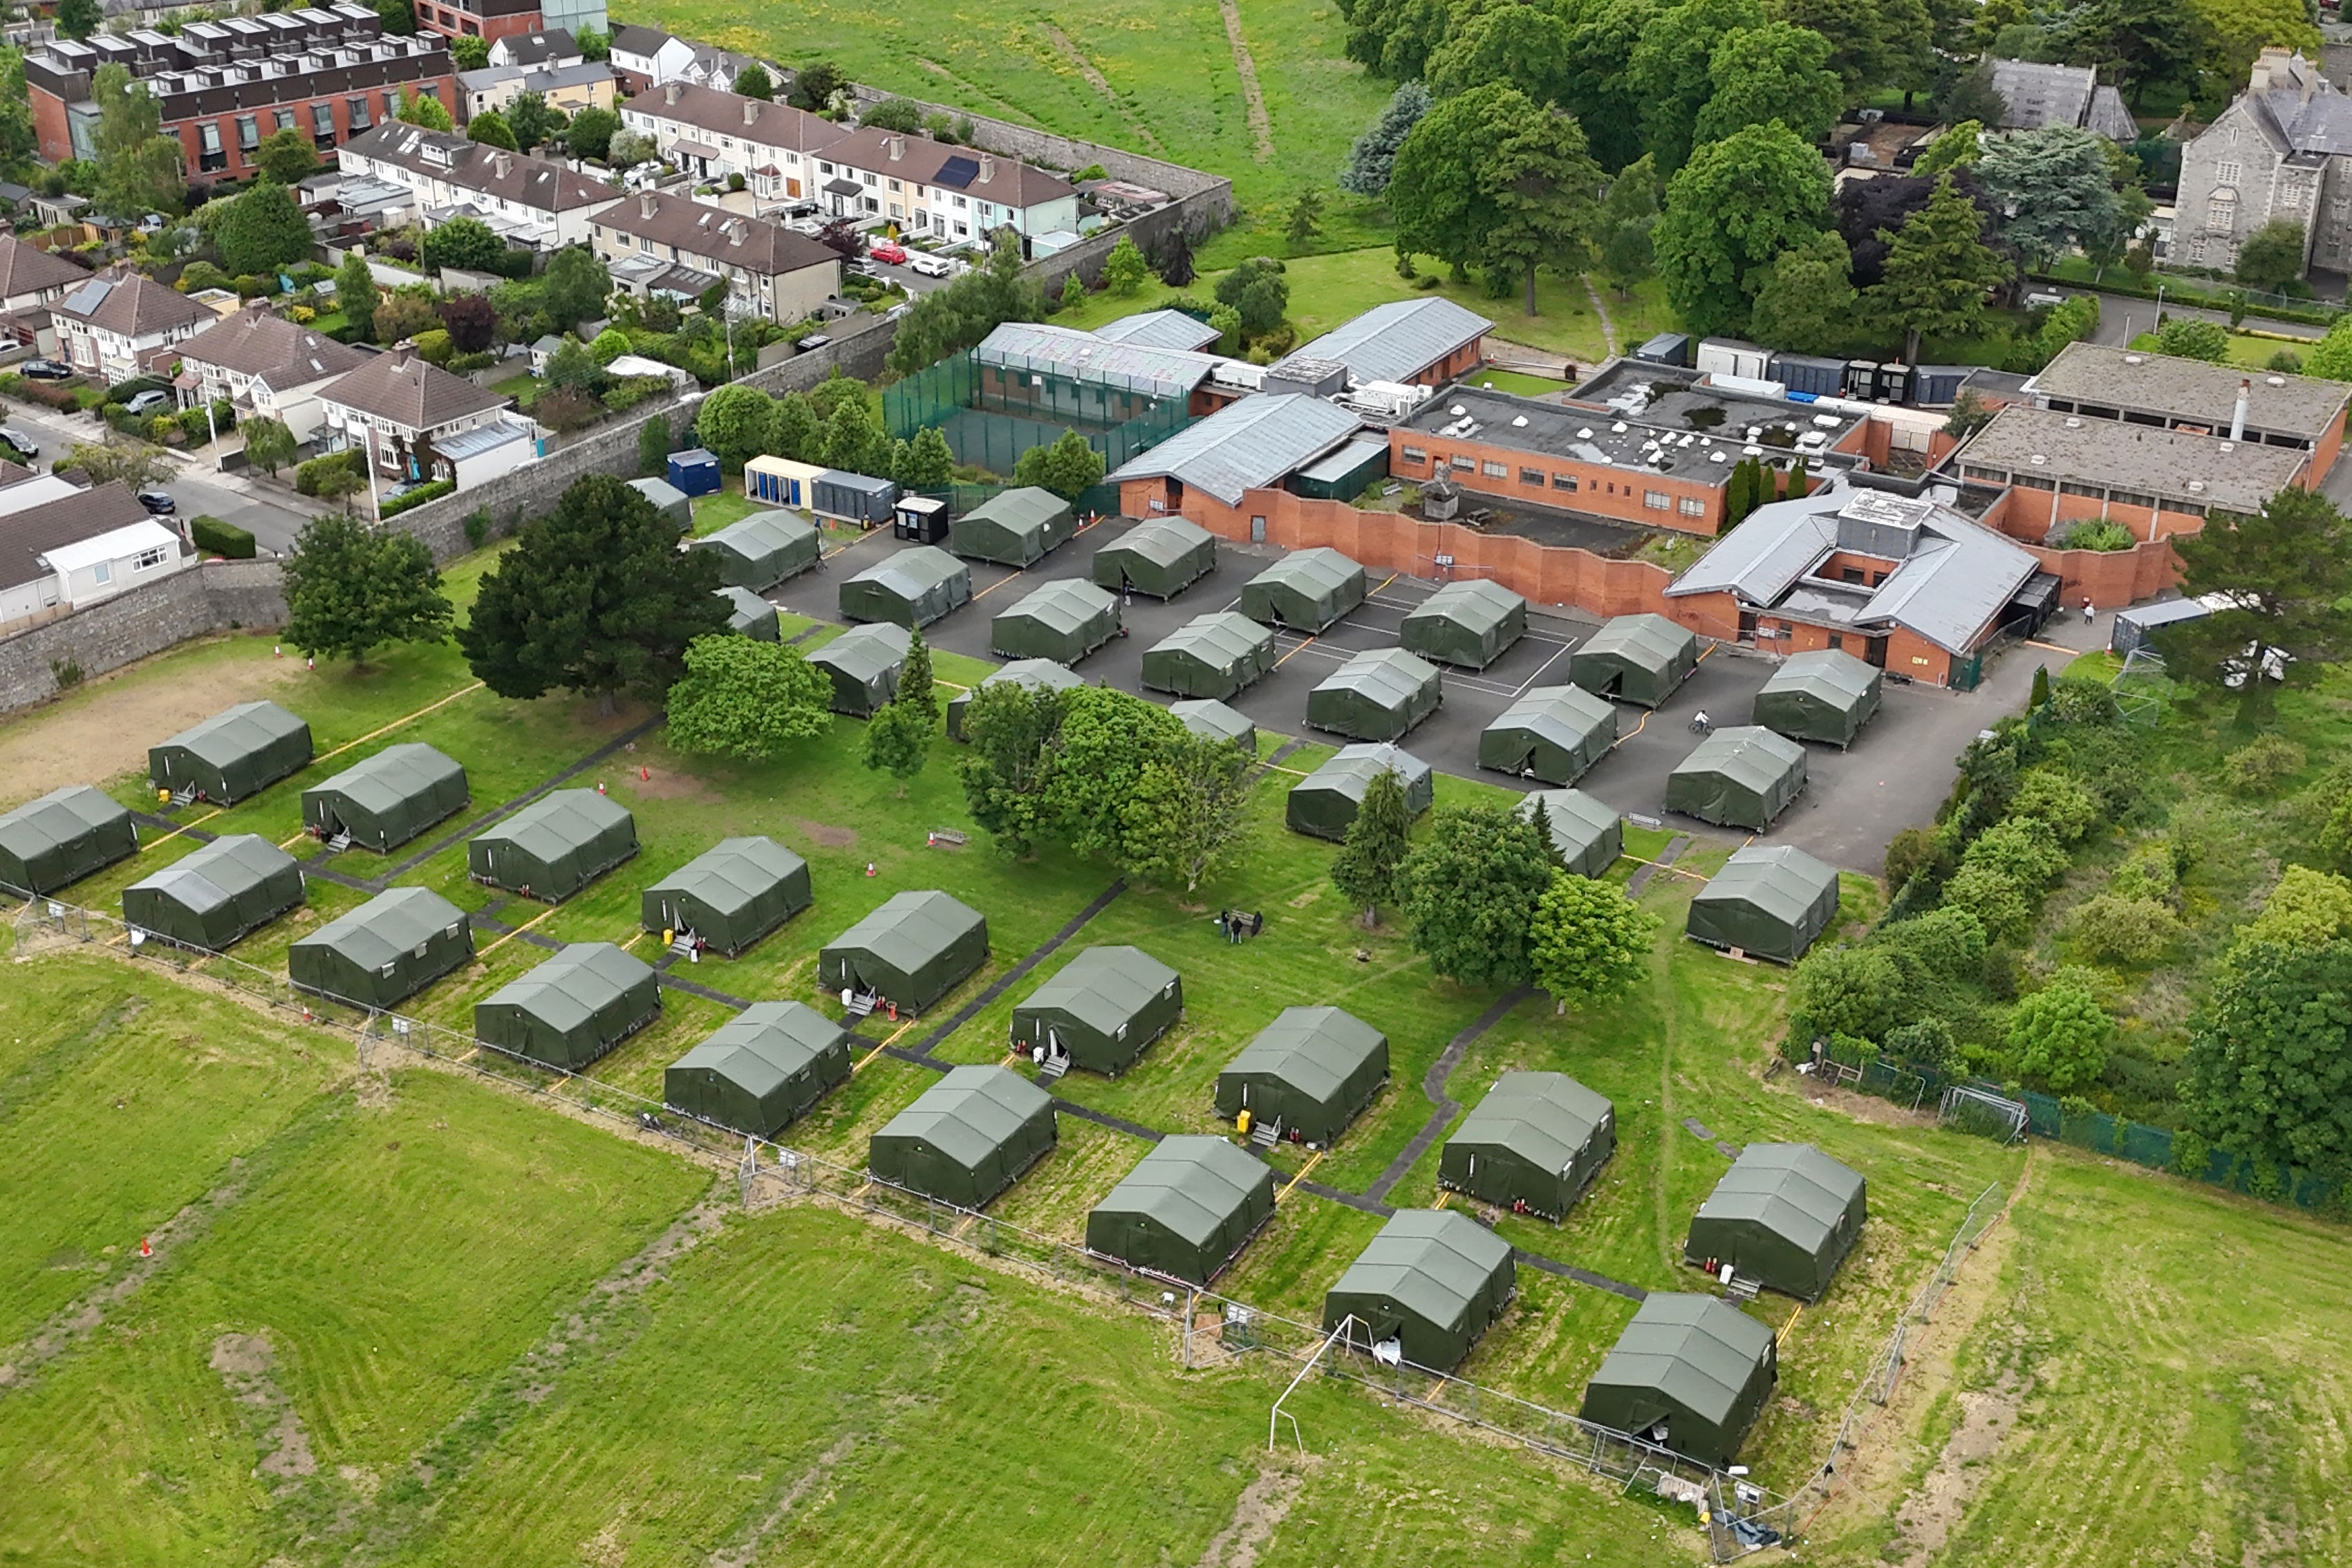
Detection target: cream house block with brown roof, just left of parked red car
<box><xmin>588</xmin><ymin>190</ymin><xmax>842</xmax><ymax>324</ymax></box>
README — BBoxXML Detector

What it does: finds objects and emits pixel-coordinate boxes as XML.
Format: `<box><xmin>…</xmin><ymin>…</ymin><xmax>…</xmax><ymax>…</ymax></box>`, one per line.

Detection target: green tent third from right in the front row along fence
<box><xmin>1087</xmin><ymin>1133</ymin><xmax>1275</xmax><ymax>1288</ymax></box>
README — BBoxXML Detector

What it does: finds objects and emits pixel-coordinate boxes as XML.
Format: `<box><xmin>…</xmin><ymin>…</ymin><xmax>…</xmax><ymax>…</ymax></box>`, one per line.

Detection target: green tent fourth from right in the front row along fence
<box><xmin>866</xmin><ymin>1067</ymin><xmax>1056</xmax><ymax>1208</ymax></box>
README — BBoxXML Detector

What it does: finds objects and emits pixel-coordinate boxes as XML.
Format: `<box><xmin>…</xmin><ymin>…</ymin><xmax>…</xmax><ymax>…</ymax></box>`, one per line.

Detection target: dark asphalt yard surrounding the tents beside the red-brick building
<box><xmin>767</xmin><ymin>519</ymin><xmax>2055</xmax><ymax>875</ymax></box>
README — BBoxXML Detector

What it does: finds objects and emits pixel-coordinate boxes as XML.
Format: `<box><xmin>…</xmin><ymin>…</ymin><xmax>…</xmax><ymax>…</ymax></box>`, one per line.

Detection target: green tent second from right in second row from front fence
<box><xmin>1437</xmin><ymin>1072</ymin><xmax>1616</xmax><ymax>1220</ymax></box>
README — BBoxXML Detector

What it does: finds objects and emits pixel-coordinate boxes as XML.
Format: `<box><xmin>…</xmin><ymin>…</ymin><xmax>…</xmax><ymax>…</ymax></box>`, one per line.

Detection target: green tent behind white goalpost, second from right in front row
<box><xmin>1324</xmin><ymin>1208</ymin><xmax>1520</xmax><ymax>1373</ymax></box>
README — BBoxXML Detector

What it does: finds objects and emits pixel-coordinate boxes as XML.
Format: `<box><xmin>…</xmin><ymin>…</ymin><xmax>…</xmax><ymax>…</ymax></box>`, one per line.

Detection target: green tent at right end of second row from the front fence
<box><xmin>1681</xmin><ymin>1143</ymin><xmax>1870</xmax><ymax>1303</ymax></box>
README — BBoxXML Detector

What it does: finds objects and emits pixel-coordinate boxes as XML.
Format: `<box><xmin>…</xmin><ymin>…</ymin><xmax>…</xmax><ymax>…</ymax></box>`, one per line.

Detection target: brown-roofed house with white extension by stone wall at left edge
<box><xmin>0</xmin><ymin>477</ymin><xmax>195</xmax><ymax>633</ymax></box>
